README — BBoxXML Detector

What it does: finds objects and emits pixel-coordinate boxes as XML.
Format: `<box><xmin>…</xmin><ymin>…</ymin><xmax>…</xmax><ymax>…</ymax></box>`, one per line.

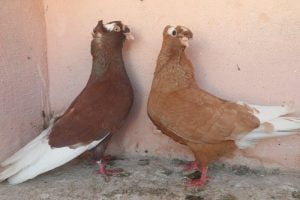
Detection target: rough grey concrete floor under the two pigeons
<box><xmin>0</xmin><ymin>157</ymin><xmax>300</xmax><ymax>200</ymax></box>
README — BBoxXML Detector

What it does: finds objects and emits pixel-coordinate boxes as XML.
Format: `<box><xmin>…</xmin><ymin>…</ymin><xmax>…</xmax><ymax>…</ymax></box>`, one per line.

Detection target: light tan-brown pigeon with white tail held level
<box><xmin>147</xmin><ymin>26</ymin><xmax>300</xmax><ymax>187</ymax></box>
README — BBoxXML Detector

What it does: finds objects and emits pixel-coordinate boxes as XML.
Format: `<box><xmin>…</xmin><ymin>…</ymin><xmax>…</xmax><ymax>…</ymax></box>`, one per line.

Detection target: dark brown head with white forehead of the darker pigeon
<box><xmin>92</xmin><ymin>20</ymin><xmax>134</xmax><ymax>44</ymax></box>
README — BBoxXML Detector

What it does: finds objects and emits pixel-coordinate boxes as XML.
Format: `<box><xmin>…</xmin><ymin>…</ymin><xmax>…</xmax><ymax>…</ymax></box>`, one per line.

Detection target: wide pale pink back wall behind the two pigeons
<box><xmin>44</xmin><ymin>0</ymin><xmax>300</xmax><ymax>169</ymax></box>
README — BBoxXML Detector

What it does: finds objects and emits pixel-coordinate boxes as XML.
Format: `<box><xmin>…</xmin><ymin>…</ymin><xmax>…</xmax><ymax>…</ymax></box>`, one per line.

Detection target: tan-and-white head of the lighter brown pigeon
<box><xmin>163</xmin><ymin>25</ymin><xmax>193</xmax><ymax>48</ymax></box>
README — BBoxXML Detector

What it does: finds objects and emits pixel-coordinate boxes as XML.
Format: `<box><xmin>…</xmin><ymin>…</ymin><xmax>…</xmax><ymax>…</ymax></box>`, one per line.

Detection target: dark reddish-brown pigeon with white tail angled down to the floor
<box><xmin>0</xmin><ymin>20</ymin><xmax>134</xmax><ymax>184</ymax></box>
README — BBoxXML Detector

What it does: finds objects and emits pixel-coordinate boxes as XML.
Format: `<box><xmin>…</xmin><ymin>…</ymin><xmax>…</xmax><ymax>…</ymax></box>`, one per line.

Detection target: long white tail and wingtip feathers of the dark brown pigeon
<box><xmin>0</xmin><ymin>120</ymin><xmax>109</xmax><ymax>184</ymax></box>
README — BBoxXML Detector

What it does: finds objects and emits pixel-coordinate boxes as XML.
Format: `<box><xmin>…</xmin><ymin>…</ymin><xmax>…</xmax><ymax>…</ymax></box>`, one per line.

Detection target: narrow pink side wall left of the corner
<box><xmin>0</xmin><ymin>0</ymin><xmax>47</xmax><ymax>162</ymax></box>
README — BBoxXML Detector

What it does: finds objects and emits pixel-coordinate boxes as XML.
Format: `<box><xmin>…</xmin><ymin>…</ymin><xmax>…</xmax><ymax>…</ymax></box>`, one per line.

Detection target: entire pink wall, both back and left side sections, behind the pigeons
<box><xmin>0</xmin><ymin>0</ymin><xmax>290</xmax><ymax>169</ymax></box>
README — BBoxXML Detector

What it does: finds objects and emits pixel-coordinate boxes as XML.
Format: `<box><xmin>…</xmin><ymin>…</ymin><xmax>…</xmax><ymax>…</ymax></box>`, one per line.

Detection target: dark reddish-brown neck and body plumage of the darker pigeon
<box><xmin>49</xmin><ymin>21</ymin><xmax>133</xmax><ymax>147</ymax></box>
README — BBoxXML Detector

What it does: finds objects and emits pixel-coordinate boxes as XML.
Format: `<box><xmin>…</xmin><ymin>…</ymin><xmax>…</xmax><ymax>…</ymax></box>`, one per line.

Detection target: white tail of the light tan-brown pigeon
<box><xmin>235</xmin><ymin>103</ymin><xmax>300</xmax><ymax>149</ymax></box>
